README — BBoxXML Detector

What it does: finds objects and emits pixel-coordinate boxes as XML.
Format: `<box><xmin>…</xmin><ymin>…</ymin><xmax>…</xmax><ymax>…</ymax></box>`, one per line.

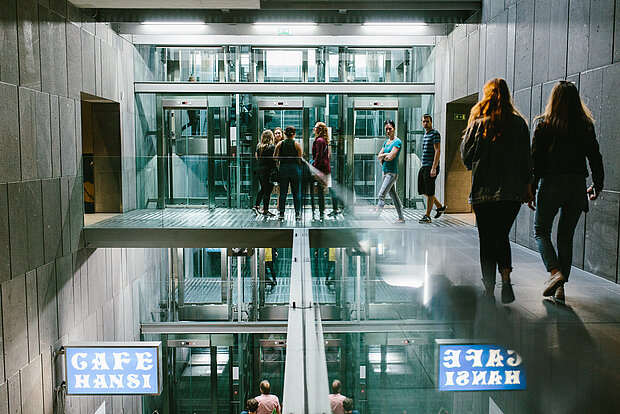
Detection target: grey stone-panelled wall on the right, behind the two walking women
<box><xmin>435</xmin><ymin>0</ymin><xmax>620</xmax><ymax>283</ymax></box>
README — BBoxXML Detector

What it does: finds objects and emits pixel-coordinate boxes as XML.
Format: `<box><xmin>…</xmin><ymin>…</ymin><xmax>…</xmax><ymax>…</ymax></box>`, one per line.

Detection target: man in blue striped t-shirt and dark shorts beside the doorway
<box><xmin>418</xmin><ymin>114</ymin><xmax>446</xmax><ymax>223</ymax></box>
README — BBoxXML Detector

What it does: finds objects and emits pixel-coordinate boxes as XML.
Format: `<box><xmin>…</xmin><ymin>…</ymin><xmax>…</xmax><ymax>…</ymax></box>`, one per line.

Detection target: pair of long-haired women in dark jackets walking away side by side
<box><xmin>461</xmin><ymin>78</ymin><xmax>604</xmax><ymax>303</ymax></box>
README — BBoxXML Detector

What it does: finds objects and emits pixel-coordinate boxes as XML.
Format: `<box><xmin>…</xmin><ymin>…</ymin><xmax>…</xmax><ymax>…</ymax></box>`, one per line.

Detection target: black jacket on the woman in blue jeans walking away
<box><xmin>532</xmin><ymin>120</ymin><xmax>605</xmax><ymax>193</ymax></box>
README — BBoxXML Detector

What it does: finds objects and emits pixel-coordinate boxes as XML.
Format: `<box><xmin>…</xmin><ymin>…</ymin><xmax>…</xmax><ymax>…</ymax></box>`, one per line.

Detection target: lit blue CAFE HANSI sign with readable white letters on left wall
<box><xmin>65</xmin><ymin>342</ymin><xmax>162</xmax><ymax>395</ymax></box>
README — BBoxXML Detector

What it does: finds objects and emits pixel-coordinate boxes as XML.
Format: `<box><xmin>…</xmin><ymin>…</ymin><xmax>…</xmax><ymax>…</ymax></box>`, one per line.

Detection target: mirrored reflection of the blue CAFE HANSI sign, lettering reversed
<box><xmin>439</xmin><ymin>345</ymin><xmax>525</xmax><ymax>391</ymax></box>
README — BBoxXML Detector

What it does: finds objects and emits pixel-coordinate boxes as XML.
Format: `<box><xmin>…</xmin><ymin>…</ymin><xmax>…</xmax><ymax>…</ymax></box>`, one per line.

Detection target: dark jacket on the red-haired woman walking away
<box><xmin>461</xmin><ymin>114</ymin><xmax>532</xmax><ymax>204</ymax></box>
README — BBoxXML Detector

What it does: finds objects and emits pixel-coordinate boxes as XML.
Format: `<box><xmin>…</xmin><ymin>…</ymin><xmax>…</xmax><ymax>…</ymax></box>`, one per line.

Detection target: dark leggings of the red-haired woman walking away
<box><xmin>473</xmin><ymin>201</ymin><xmax>521</xmax><ymax>289</ymax></box>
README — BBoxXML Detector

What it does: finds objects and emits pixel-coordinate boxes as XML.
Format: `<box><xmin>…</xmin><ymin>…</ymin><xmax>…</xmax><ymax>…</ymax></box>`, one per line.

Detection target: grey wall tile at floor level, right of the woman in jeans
<box><xmin>584</xmin><ymin>191</ymin><xmax>620</xmax><ymax>282</ymax></box>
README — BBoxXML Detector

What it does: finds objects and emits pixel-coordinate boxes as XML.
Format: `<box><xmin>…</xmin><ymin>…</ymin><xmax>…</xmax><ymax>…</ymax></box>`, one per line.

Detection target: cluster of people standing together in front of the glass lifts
<box><xmin>253</xmin><ymin>122</ymin><xmax>339</xmax><ymax>220</ymax></box>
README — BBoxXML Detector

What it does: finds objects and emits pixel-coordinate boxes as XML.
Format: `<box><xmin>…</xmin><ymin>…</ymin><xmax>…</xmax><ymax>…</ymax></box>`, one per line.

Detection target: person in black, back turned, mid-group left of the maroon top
<box><xmin>275</xmin><ymin>126</ymin><xmax>302</xmax><ymax>220</ymax></box>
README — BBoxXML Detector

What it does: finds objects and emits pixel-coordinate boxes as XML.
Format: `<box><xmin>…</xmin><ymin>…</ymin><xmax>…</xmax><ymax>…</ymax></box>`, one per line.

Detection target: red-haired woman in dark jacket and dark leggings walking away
<box><xmin>461</xmin><ymin>78</ymin><xmax>533</xmax><ymax>303</ymax></box>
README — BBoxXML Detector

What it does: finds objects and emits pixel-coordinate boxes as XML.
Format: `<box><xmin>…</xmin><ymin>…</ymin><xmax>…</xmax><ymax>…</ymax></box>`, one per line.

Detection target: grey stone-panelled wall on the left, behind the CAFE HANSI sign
<box><xmin>0</xmin><ymin>0</ymin><xmax>165</xmax><ymax>413</ymax></box>
